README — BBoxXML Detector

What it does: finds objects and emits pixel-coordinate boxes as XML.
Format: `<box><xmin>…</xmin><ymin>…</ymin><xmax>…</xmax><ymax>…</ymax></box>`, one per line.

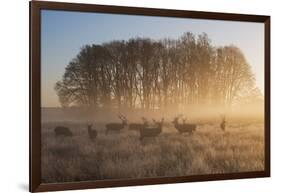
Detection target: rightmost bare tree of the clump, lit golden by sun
<box><xmin>212</xmin><ymin>46</ymin><xmax>255</xmax><ymax>106</ymax></box>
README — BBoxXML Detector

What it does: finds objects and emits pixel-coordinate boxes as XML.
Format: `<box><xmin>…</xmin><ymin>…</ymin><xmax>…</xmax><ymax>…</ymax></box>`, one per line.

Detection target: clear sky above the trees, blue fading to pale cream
<box><xmin>41</xmin><ymin>10</ymin><xmax>264</xmax><ymax>107</ymax></box>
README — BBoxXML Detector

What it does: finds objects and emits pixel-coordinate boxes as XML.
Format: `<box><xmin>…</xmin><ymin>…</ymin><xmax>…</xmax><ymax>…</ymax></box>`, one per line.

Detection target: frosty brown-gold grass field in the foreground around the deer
<box><xmin>42</xmin><ymin>122</ymin><xmax>264</xmax><ymax>183</ymax></box>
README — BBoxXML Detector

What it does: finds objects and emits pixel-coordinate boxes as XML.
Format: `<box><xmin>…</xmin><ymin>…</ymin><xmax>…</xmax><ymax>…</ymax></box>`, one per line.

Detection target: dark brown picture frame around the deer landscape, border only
<box><xmin>29</xmin><ymin>1</ymin><xmax>270</xmax><ymax>192</ymax></box>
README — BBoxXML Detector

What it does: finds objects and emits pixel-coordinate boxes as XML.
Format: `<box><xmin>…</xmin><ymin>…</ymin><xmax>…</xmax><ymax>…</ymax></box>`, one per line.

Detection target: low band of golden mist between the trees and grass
<box><xmin>41</xmin><ymin>101</ymin><xmax>264</xmax><ymax>123</ymax></box>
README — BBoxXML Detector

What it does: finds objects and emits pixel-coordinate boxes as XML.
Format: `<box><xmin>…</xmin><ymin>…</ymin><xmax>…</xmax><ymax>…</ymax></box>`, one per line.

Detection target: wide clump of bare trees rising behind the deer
<box><xmin>55</xmin><ymin>32</ymin><xmax>256</xmax><ymax>109</ymax></box>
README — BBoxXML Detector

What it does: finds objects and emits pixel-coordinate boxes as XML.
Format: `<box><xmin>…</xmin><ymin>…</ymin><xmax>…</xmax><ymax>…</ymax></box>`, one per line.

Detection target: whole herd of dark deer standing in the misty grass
<box><xmin>54</xmin><ymin>115</ymin><xmax>226</xmax><ymax>140</ymax></box>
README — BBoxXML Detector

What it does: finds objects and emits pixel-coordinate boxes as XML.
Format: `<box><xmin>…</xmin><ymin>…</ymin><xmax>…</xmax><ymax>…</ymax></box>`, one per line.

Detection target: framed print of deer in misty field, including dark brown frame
<box><xmin>30</xmin><ymin>1</ymin><xmax>270</xmax><ymax>192</ymax></box>
